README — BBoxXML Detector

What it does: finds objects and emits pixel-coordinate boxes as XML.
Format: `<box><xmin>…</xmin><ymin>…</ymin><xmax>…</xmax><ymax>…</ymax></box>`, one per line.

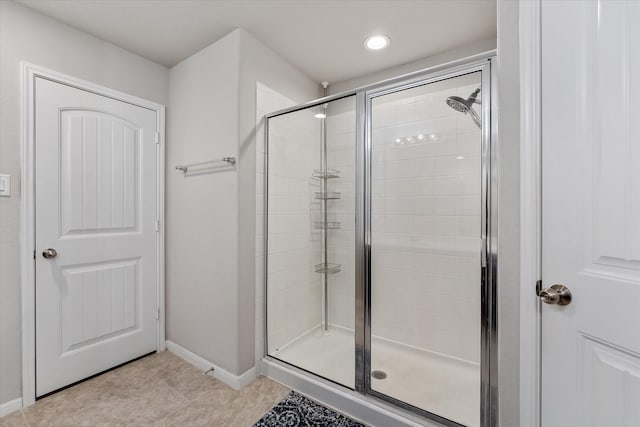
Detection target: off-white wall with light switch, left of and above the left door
<box><xmin>0</xmin><ymin>1</ymin><xmax>169</xmax><ymax>403</ymax></box>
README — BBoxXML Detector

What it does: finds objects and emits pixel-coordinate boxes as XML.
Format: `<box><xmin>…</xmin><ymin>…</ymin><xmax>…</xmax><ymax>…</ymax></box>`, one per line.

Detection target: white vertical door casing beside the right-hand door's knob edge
<box><xmin>518</xmin><ymin>0</ymin><xmax>542</xmax><ymax>427</ymax></box>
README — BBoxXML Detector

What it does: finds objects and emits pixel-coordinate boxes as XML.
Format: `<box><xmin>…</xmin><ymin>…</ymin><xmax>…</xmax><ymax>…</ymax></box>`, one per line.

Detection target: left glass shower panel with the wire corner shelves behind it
<box><xmin>266</xmin><ymin>96</ymin><xmax>356</xmax><ymax>388</ymax></box>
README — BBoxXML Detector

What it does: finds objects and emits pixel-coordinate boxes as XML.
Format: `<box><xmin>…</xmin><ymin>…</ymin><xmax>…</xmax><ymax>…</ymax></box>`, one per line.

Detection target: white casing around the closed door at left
<box><xmin>20</xmin><ymin>62</ymin><xmax>165</xmax><ymax>407</ymax></box>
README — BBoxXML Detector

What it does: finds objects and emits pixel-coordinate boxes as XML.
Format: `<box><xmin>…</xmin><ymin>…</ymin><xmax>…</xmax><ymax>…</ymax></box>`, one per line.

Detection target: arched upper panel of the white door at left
<box><xmin>60</xmin><ymin>110</ymin><xmax>140</xmax><ymax>235</ymax></box>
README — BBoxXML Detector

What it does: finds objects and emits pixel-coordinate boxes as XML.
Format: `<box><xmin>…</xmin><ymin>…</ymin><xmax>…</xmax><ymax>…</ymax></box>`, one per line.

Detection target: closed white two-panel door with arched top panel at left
<box><xmin>35</xmin><ymin>78</ymin><xmax>158</xmax><ymax>396</ymax></box>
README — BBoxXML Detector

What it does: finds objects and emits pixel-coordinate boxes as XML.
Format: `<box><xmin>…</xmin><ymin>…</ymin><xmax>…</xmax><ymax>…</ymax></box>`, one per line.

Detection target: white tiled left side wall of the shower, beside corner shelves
<box><xmin>256</xmin><ymin>83</ymin><xmax>321</xmax><ymax>360</ymax></box>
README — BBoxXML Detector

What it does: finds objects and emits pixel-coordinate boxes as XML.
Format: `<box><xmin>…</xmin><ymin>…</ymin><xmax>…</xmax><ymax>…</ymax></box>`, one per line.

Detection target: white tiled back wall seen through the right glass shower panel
<box><xmin>368</xmin><ymin>77</ymin><xmax>481</xmax><ymax>363</ymax></box>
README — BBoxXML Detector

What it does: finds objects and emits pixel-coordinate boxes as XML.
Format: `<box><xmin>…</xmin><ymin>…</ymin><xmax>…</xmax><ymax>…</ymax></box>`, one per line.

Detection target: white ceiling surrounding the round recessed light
<box><xmin>17</xmin><ymin>0</ymin><xmax>496</xmax><ymax>82</ymax></box>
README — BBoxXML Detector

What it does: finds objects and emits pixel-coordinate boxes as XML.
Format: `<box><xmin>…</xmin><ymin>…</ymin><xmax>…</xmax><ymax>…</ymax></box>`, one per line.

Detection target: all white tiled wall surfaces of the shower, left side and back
<box><xmin>256</xmin><ymin>79</ymin><xmax>481</xmax><ymax>363</ymax></box>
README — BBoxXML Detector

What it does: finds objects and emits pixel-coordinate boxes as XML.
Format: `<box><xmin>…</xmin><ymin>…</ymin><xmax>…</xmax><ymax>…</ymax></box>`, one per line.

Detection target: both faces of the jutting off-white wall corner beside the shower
<box><xmin>167</xmin><ymin>29</ymin><xmax>318</xmax><ymax>375</ymax></box>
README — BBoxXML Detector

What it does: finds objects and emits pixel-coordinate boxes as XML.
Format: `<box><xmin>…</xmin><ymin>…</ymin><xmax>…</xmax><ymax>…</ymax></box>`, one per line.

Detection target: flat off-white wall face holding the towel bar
<box><xmin>166</xmin><ymin>33</ymin><xmax>240</xmax><ymax>373</ymax></box>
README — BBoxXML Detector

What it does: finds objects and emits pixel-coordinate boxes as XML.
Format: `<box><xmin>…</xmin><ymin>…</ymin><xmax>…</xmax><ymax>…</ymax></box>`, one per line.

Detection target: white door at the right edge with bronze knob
<box><xmin>541</xmin><ymin>0</ymin><xmax>640</xmax><ymax>427</ymax></box>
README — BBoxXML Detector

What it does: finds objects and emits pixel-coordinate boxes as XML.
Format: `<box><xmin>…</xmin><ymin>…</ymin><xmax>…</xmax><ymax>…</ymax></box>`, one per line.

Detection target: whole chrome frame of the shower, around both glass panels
<box><xmin>262</xmin><ymin>56</ymin><xmax>498</xmax><ymax>427</ymax></box>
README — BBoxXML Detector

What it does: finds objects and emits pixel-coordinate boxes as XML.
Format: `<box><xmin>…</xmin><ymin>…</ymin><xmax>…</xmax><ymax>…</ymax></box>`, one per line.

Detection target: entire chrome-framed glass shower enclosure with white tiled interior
<box><xmin>264</xmin><ymin>57</ymin><xmax>497</xmax><ymax>427</ymax></box>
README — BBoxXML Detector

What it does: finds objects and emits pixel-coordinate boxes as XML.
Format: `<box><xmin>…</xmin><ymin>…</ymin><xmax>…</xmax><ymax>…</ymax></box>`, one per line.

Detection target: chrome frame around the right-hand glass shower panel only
<box><xmin>355</xmin><ymin>58</ymin><xmax>498</xmax><ymax>427</ymax></box>
